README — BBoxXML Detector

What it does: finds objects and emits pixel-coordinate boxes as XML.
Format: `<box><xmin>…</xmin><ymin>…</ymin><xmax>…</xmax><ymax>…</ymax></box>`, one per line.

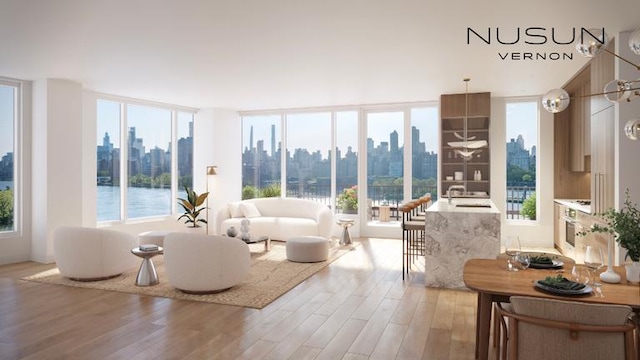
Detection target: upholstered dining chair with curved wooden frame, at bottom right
<box><xmin>496</xmin><ymin>296</ymin><xmax>637</xmax><ymax>360</ymax></box>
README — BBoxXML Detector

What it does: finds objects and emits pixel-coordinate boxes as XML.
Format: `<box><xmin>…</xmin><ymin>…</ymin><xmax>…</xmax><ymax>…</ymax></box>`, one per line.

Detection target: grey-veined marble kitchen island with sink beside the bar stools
<box><xmin>424</xmin><ymin>198</ymin><xmax>500</xmax><ymax>289</ymax></box>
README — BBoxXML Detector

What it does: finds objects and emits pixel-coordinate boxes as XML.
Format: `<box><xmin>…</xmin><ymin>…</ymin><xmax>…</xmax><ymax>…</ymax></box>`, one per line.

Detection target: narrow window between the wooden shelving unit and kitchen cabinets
<box><xmin>506</xmin><ymin>101</ymin><xmax>538</xmax><ymax>220</ymax></box>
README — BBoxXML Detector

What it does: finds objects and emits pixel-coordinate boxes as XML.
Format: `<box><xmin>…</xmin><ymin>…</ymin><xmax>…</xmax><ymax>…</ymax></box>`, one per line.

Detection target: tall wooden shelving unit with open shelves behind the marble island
<box><xmin>440</xmin><ymin>92</ymin><xmax>491</xmax><ymax>197</ymax></box>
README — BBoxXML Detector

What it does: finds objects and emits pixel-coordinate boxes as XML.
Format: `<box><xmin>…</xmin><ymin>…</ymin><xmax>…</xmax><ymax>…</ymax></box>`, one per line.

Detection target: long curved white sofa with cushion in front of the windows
<box><xmin>216</xmin><ymin>198</ymin><xmax>333</xmax><ymax>241</ymax></box>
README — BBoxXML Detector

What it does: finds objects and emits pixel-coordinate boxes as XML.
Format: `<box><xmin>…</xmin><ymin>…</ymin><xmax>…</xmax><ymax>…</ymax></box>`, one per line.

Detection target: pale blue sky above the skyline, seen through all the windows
<box><xmin>0</xmin><ymin>93</ymin><xmax>538</xmax><ymax>162</ymax></box>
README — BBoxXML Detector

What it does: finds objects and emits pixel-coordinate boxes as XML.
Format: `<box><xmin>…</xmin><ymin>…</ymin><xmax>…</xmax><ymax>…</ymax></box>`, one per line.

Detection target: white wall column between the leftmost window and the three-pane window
<box><xmin>31</xmin><ymin>79</ymin><xmax>84</xmax><ymax>263</ymax></box>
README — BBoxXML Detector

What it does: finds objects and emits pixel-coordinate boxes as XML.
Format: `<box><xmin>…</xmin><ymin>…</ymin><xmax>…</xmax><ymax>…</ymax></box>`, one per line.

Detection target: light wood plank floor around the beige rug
<box><xmin>0</xmin><ymin>239</ymin><xmax>476</xmax><ymax>360</ymax></box>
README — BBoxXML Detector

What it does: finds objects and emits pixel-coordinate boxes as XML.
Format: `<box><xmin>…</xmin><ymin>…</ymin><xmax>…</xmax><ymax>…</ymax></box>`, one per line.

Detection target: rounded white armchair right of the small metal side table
<box><xmin>164</xmin><ymin>232</ymin><xmax>251</xmax><ymax>294</ymax></box>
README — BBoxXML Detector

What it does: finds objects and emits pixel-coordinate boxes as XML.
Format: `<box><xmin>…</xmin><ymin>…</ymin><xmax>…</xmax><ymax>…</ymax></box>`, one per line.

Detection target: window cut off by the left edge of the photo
<box><xmin>0</xmin><ymin>78</ymin><xmax>21</xmax><ymax>234</ymax></box>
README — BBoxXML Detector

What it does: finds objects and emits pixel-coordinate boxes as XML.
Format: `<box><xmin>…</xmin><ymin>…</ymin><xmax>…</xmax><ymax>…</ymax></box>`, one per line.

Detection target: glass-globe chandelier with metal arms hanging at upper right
<box><xmin>542</xmin><ymin>28</ymin><xmax>640</xmax><ymax>140</ymax></box>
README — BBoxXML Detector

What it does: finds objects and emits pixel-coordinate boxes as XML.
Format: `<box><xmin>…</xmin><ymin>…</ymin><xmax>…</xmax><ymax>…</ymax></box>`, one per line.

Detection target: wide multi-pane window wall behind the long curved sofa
<box><xmin>241</xmin><ymin>105</ymin><xmax>438</xmax><ymax>221</ymax></box>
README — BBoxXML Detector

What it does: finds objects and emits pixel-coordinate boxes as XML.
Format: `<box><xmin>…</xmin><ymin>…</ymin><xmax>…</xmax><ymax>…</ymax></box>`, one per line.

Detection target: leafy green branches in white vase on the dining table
<box><xmin>590</xmin><ymin>189</ymin><xmax>640</xmax><ymax>282</ymax></box>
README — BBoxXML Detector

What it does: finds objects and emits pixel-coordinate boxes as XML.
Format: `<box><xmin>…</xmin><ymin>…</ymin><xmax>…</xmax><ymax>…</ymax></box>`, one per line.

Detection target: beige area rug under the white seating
<box><xmin>23</xmin><ymin>242</ymin><xmax>360</xmax><ymax>309</ymax></box>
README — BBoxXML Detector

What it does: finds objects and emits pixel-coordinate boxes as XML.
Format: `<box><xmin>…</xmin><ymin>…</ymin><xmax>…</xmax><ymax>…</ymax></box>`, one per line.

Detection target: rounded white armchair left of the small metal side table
<box><xmin>53</xmin><ymin>226</ymin><xmax>140</xmax><ymax>281</ymax></box>
